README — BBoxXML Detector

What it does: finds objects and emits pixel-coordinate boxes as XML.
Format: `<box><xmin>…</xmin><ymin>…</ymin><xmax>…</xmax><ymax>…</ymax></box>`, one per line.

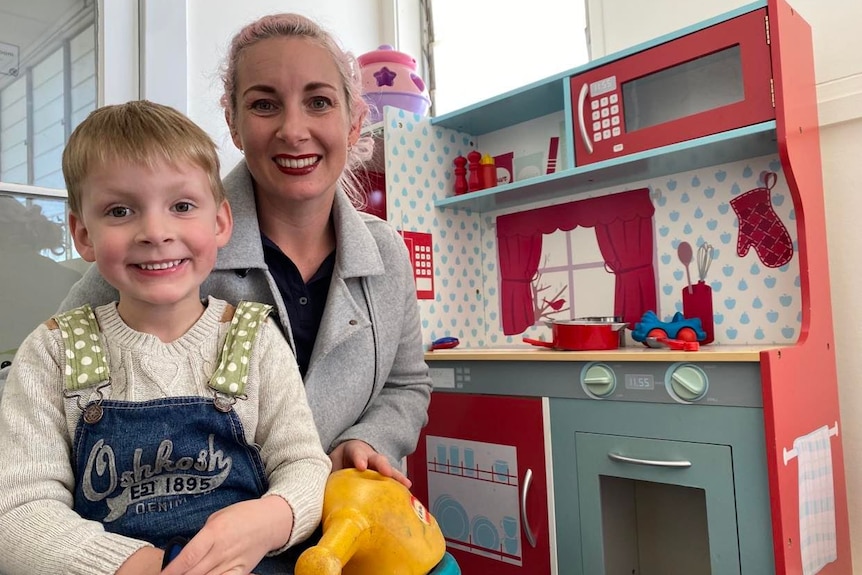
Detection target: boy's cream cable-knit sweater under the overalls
<box><xmin>0</xmin><ymin>298</ymin><xmax>331</xmax><ymax>575</ymax></box>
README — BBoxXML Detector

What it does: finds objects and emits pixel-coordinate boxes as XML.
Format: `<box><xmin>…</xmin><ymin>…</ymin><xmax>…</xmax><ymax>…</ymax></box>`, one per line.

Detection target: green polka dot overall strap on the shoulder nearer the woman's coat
<box><xmin>210</xmin><ymin>301</ymin><xmax>272</xmax><ymax>397</ymax></box>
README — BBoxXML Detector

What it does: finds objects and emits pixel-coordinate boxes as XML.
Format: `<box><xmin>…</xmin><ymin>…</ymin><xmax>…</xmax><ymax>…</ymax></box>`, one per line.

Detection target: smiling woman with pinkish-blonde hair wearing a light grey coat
<box><xmin>61</xmin><ymin>14</ymin><xmax>431</xmax><ymax>486</ymax></box>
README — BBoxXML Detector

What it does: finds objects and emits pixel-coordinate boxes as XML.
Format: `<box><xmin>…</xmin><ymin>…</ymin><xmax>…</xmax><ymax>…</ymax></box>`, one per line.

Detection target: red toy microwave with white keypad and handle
<box><xmin>571</xmin><ymin>8</ymin><xmax>775</xmax><ymax>166</ymax></box>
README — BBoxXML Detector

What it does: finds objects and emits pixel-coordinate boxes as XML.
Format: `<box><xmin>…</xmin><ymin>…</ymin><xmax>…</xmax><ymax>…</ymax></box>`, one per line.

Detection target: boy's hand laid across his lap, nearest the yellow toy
<box><xmin>162</xmin><ymin>495</ymin><xmax>293</xmax><ymax>575</ymax></box>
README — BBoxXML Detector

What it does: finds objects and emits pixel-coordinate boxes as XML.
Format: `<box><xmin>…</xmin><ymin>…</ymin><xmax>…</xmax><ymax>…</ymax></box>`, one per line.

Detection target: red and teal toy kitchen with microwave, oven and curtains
<box><xmin>362</xmin><ymin>0</ymin><xmax>852</xmax><ymax>575</ymax></box>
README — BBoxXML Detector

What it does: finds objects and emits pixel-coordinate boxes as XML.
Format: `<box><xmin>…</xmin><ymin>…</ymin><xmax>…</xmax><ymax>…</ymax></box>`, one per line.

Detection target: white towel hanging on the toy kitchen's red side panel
<box><xmin>793</xmin><ymin>425</ymin><xmax>838</xmax><ymax>575</ymax></box>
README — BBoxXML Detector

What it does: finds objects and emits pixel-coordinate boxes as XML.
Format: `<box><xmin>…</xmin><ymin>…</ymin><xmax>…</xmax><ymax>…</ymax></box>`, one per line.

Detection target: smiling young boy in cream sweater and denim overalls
<box><xmin>0</xmin><ymin>101</ymin><xmax>331</xmax><ymax>575</ymax></box>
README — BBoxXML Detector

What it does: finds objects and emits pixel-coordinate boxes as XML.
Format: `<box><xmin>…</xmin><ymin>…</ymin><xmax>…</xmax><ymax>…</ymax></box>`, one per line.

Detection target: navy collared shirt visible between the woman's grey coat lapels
<box><xmin>261</xmin><ymin>234</ymin><xmax>335</xmax><ymax>377</ymax></box>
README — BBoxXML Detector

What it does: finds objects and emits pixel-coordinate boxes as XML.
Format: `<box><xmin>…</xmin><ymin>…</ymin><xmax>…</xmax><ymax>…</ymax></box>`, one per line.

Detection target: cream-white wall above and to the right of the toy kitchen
<box><xmin>587</xmin><ymin>0</ymin><xmax>862</xmax><ymax>573</ymax></box>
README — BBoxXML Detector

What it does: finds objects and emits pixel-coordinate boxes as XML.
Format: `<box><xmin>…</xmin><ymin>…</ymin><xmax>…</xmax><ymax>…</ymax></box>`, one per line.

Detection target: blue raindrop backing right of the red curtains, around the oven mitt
<box><xmin>650</xmin><ymin>156</ymin><xmax>802</xmax><ymax>344</ymax></box>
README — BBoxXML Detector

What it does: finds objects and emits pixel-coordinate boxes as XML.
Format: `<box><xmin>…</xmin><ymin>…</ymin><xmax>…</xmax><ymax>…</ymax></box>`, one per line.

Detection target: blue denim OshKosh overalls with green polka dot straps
<box><xmin>55</xmin><ymin>302</ymin><xmax>292</xmax><ymax>575</ymax></box>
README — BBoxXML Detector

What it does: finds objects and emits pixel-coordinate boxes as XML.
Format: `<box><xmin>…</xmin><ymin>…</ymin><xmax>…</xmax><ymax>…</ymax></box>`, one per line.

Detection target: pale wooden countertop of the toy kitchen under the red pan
<box><xmin>425</xmin><ymin>344</ymin><xmax>792</xmax><ymax>362</ymax></box>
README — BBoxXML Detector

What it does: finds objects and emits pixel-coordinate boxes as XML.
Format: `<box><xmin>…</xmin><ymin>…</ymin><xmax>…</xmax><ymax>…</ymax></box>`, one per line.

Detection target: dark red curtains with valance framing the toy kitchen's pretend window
<box><xmin>497</xmin><ymin>188</ymin><xmax>656</xmax><ymax>335</ymax></box>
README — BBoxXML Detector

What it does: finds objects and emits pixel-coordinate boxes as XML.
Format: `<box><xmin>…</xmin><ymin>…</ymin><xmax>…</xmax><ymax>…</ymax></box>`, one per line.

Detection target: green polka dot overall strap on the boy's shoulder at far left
<box><xmin>54</xmin><ymin>305</ymin><xmax>110</xmax><ymax>391</ymax></box>
